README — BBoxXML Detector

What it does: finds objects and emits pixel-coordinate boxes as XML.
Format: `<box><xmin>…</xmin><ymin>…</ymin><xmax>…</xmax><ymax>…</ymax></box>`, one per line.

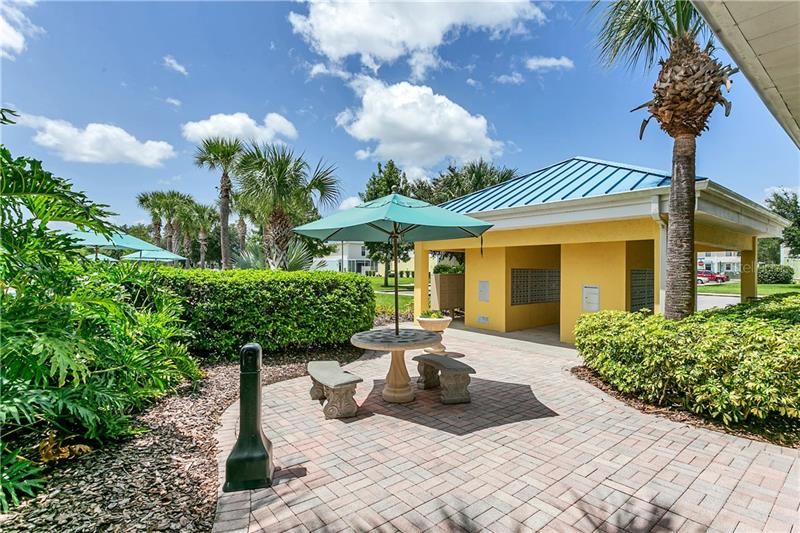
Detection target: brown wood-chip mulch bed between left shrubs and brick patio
<box><xmin>0</xmin><ymin>346</ymin><xmax>363</xmax><ymax>533</ymax></box>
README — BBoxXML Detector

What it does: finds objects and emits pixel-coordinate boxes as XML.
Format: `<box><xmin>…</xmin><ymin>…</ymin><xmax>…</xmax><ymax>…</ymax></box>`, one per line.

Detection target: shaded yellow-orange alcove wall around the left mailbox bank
<box><xmin>505</xmin><ymin>245</ymin><xmax>561</xmax><ymax>331</ymax></box>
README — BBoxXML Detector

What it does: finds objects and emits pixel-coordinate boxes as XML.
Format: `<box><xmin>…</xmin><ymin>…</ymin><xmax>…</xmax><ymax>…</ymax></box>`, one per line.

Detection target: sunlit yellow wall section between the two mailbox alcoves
<box><xmin>561</xmin><ymin>241</ymin><xmax>628</xmax><ymax>342</ymax></box>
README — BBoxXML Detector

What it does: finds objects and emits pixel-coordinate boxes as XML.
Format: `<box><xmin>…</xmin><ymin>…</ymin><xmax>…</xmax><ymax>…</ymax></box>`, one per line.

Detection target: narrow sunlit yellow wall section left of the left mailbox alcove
<box><xmin>464</xmin><ymin>248</ymin><xmax>506</xmax><ymax>331</ymax></box>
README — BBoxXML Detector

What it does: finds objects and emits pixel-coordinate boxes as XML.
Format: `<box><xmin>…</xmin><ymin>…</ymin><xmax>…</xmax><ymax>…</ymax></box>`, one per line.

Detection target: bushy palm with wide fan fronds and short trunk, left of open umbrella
<box><xmin>236</xmin><ymin>143</ymin><xmax>339</xmax><ymax>270</ymax></box>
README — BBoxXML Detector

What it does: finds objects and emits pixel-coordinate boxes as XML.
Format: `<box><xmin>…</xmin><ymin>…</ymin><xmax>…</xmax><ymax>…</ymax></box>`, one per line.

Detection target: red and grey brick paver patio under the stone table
<box><xmin>214</xmin><ymin>329</ymin><xmax>800</xmax><ymax>532</ymax></box>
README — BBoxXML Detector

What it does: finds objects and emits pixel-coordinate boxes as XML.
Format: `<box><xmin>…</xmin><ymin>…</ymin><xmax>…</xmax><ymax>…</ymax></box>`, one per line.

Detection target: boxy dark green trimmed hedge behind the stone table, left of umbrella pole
<box><xmin>162</xmin><ymin>268</ymin><xmax>375</xmax><ymax>359</ymax></box>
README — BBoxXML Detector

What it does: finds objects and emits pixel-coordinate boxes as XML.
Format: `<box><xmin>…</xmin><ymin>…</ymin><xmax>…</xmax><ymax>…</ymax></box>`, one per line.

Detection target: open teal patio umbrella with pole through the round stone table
<box><xmin>294</xmin><ymin>193</ymin><xmax>492</xmax><ymax>335</ymax></box>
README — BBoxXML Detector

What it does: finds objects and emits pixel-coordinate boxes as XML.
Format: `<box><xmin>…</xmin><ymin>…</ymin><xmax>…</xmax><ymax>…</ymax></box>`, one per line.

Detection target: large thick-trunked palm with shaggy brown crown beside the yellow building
<box><xmin>592</xmin><ymin>0</ymin><xmax>738</xmax><ymax>319</ymax></box>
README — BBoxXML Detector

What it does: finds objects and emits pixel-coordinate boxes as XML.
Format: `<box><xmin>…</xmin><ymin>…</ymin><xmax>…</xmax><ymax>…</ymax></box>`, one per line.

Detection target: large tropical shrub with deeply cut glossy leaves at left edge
<box><xmin>0</xmin><ymin>144</ymin><xmax>199</xmax><ymax>511</ymax></box>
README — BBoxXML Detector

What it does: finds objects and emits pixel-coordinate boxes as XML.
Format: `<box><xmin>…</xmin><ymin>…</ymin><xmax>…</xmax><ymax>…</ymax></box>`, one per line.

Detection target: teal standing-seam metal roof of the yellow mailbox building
<box><xmin>441</xmin><ymin>157</ymin><xmax>708</xmax><ymax>213</ymax></box>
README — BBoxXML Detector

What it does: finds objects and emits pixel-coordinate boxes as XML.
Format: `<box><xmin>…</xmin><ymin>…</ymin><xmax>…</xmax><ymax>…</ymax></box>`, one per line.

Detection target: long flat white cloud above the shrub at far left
<box><xmin>19</xmin><ymin>114</ymin><xmax>175</xmax><ymax>167</ymax></box>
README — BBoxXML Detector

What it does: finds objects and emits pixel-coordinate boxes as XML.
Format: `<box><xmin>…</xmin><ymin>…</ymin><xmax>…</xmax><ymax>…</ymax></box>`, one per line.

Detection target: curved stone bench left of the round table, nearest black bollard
<box><xmin>307</xmin><ymin>361</ymin><xmax>364</xmax><ymax>418</ymax></box>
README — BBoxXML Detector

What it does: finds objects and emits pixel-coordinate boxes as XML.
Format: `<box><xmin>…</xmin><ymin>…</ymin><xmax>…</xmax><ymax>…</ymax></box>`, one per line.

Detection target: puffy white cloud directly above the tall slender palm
<box><xmin>181</xmin><ymin>113</ymin><xmax>297</xmax><ymax>143</ymax></box>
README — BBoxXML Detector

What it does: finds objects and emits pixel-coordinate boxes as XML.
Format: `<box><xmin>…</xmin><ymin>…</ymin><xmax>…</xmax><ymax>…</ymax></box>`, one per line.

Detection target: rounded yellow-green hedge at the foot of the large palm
<box><xmin>575</xmin><ymin>294</ymin><xmax>800</xmax><ymax>436</ymax></box>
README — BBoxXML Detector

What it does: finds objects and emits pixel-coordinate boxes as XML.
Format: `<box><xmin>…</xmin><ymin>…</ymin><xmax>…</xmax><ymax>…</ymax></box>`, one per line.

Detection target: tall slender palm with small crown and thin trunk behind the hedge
<box><xmin>194</xmin><ymin>137</ymin><xmax>242</xmax><ymax>270</ymax></box>
